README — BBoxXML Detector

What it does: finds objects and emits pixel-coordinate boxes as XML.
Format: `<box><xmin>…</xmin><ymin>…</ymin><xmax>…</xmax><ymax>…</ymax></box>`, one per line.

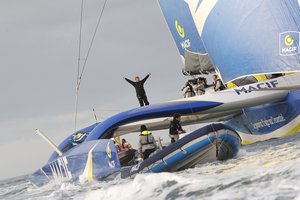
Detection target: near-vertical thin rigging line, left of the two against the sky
<box><xmin>74</xmin><ymin>0</ymin><xmax>84</xmax><ymax>131</ymax></box>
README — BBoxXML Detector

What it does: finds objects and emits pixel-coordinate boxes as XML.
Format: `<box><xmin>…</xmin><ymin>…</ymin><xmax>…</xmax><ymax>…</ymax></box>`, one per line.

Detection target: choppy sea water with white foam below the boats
<box><xmin>0</xmin><ymin>134</ymin><xmax>300</xmax><ymax>200</ymax></box>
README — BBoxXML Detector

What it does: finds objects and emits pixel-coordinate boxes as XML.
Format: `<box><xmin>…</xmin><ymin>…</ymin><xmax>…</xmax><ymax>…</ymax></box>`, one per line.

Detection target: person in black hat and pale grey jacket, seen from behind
<box><xmin>139</xmin><ymin>125</ymin><xmax>157</xmax><ymax>160</ymax></box>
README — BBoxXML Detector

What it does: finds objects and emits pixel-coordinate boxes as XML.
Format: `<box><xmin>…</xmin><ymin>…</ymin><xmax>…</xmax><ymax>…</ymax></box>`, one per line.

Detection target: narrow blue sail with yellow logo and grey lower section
<box><xmin>159</xmin><ymin>0</ymin><xmax>214</xmax><ymax>74</ymax></box>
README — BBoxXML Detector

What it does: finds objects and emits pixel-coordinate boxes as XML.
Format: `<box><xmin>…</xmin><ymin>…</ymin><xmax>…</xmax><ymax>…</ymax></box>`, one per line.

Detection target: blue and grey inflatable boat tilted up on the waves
<box><xmin>121</xmin><ymin>124</ymin><xmax>241</xmax><ymax>178</ymax></box>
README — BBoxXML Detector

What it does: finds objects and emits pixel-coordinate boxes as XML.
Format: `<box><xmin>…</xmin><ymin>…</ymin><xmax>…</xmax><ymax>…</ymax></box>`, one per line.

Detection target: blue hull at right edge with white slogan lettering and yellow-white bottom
<box><xmin>225</xmin><ymin>90</ymin><xmax>300</xmax><ymax>144</ymax></box>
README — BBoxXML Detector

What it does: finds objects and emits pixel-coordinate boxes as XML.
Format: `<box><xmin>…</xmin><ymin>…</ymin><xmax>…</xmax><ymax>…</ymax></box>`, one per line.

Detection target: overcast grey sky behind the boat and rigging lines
<box><xmin>0</xmin><ymin>0</ymin><xmax>187</xmax><ymax>179</ymax></box>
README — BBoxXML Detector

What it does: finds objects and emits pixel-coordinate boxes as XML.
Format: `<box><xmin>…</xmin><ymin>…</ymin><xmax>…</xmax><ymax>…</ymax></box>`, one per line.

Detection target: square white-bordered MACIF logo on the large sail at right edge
<box><xmin>279</xmin><ymin>31</ymin><xmax>300</xmax><ymax>56</ymax></box>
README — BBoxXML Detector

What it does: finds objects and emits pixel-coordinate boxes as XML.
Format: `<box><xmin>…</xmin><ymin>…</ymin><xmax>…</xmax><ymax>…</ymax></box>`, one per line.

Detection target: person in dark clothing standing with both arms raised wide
<box><xmin>124</xmin><ymin>74</ymin><xmax>151</xmax><ymax>106</ymax></box>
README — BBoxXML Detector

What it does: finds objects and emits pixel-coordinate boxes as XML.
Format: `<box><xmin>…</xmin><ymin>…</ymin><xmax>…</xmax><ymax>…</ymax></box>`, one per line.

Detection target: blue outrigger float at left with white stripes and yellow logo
<box><xmin>28</xmin><ymin>139</ymin><xmax>121</xmax><ymax>186</ymax></box>
